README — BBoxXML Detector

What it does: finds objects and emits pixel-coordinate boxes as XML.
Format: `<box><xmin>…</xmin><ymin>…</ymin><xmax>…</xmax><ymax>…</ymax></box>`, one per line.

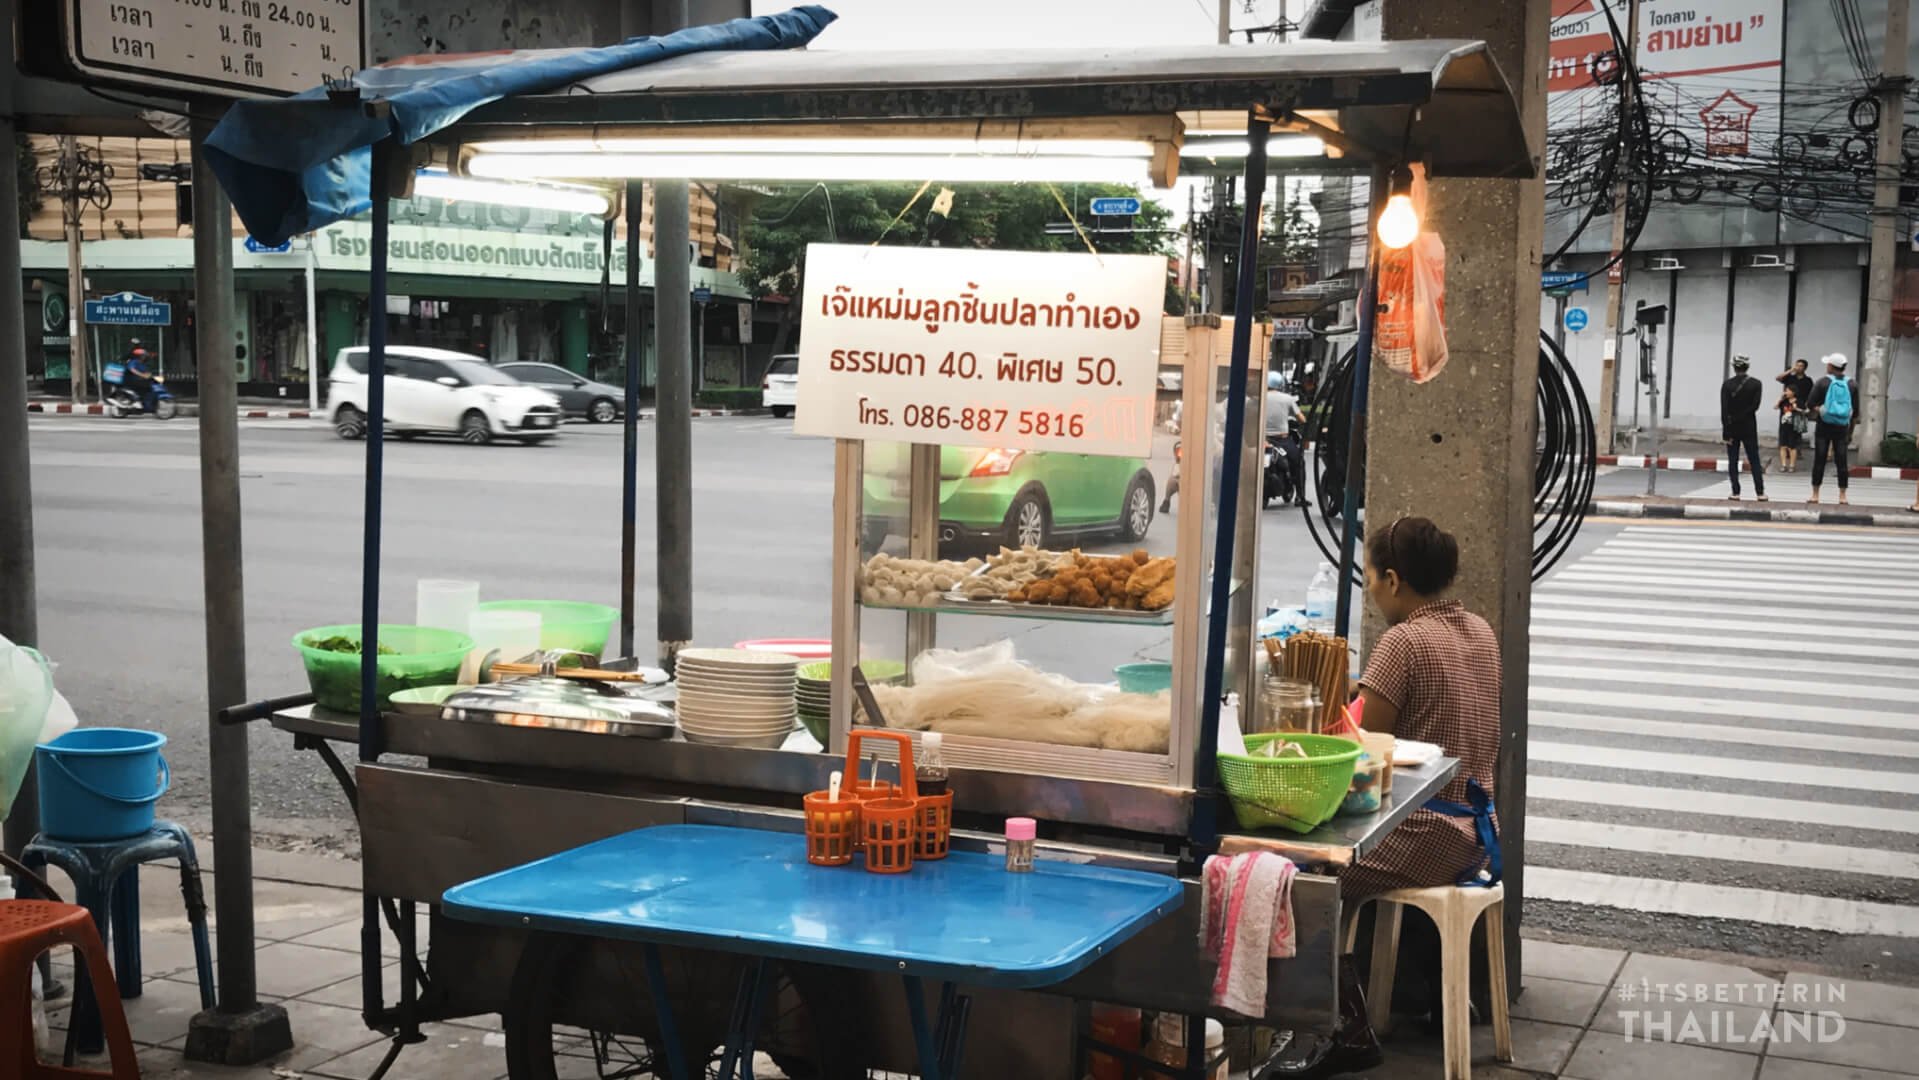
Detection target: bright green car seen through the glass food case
<box><xmin>862</xmin><ymin>443</ymin><xmax>1155</xmax><ymax>551</ymax></box>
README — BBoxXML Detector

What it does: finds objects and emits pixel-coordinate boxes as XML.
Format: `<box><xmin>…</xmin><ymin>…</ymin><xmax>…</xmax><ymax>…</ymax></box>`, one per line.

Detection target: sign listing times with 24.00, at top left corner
<box><xmin>68</xmin><ymin>0</ymin><xmax>365</xmax><ymax>98</ymax></box>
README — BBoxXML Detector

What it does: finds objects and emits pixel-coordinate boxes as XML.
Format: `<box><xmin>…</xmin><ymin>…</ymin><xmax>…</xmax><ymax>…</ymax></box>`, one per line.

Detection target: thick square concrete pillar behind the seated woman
<box><xmin>1366</xmin><ymin>0</ymin><xmax>1547</xmax><ymax>990</ymax></box>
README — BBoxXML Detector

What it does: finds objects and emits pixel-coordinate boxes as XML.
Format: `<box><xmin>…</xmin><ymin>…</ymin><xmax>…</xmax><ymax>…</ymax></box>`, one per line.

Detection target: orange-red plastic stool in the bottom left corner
<box><xmin>0</xmin><ymin>900</ymin><xmax>140</xmax><ymax>1080</ymax></box>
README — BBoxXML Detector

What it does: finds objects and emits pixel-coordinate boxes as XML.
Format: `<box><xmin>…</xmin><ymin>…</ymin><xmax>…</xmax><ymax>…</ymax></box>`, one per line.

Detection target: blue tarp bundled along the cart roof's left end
<box><xmin>205</xmin><ymin>4</ymin><xmax>835</xmax><ymax>246</ymax></box>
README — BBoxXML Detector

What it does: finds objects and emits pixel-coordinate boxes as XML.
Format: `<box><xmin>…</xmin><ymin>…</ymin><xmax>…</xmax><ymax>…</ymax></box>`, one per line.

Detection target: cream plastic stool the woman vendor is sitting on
<box><xmin>1345</xmin><ymin>884</ymin><xmax>1512</xmax><ymax>1080</ymax></box>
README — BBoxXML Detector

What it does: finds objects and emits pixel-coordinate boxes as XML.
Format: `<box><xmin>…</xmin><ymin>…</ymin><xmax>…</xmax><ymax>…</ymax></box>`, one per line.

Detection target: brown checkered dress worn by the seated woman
<box><xmin>1339</xmin><ymin>600</ymin><xmax>1501</xmax><ymax>902</ymax></box>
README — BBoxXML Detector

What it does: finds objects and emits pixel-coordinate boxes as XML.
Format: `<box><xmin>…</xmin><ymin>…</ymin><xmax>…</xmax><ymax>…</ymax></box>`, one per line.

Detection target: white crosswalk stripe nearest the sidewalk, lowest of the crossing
<box><xmin>1526</xmin><ymin>815</ymin><xmax>1919</xmax><ymax>879</ymax></box>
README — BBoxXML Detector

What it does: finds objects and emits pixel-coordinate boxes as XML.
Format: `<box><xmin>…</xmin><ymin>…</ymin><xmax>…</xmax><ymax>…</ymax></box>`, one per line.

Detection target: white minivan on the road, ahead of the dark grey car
<box><xmin>326</xmin><ymin>345</ymin><xmax>560</xmax><ymax>443</ymax></box>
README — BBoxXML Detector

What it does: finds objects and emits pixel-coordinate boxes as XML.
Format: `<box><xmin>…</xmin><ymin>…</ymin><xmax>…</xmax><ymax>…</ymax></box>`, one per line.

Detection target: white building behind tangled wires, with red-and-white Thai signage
<box><xmin>1305</xmin><ymin>0</ymin><xmax>1919</xmax><ymax>441</ymax></box>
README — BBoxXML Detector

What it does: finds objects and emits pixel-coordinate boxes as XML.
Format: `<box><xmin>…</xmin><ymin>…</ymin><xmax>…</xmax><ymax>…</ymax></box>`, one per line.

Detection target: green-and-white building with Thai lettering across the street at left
<box><xmin>21</xmin><ymin>136</ymin><xmax>775</xmax><ymax>401</ymax></box>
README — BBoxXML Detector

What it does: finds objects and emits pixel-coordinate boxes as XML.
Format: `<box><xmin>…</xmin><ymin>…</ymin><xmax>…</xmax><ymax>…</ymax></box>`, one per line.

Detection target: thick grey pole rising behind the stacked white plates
<box><xmin>652</xmin><ymin>178</ymin><xmax>693</xmax><ymax>669</ymax></box>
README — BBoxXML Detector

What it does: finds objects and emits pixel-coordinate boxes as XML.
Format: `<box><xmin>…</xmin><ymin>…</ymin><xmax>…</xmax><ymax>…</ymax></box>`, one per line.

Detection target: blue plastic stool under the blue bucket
<box><xmin>19</xmin><ymin>821</ymin><xmax>213</xmax><ymax>1053</ymax></box>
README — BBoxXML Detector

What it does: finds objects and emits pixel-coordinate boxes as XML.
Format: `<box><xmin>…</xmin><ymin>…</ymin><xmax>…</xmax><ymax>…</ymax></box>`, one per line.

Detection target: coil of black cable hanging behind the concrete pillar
<box><xmin>1299</xmin><ymin>334</ymin><xmax>1599</xmax><ymax>583</ymax></box>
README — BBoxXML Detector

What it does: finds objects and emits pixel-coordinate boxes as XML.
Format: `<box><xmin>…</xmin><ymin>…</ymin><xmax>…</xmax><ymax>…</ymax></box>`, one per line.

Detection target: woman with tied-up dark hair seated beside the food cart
<box><xmin>1267</xmin><ymin>518</ymin><xmax>1501</xmax><ymax>1076</ymax></box>
